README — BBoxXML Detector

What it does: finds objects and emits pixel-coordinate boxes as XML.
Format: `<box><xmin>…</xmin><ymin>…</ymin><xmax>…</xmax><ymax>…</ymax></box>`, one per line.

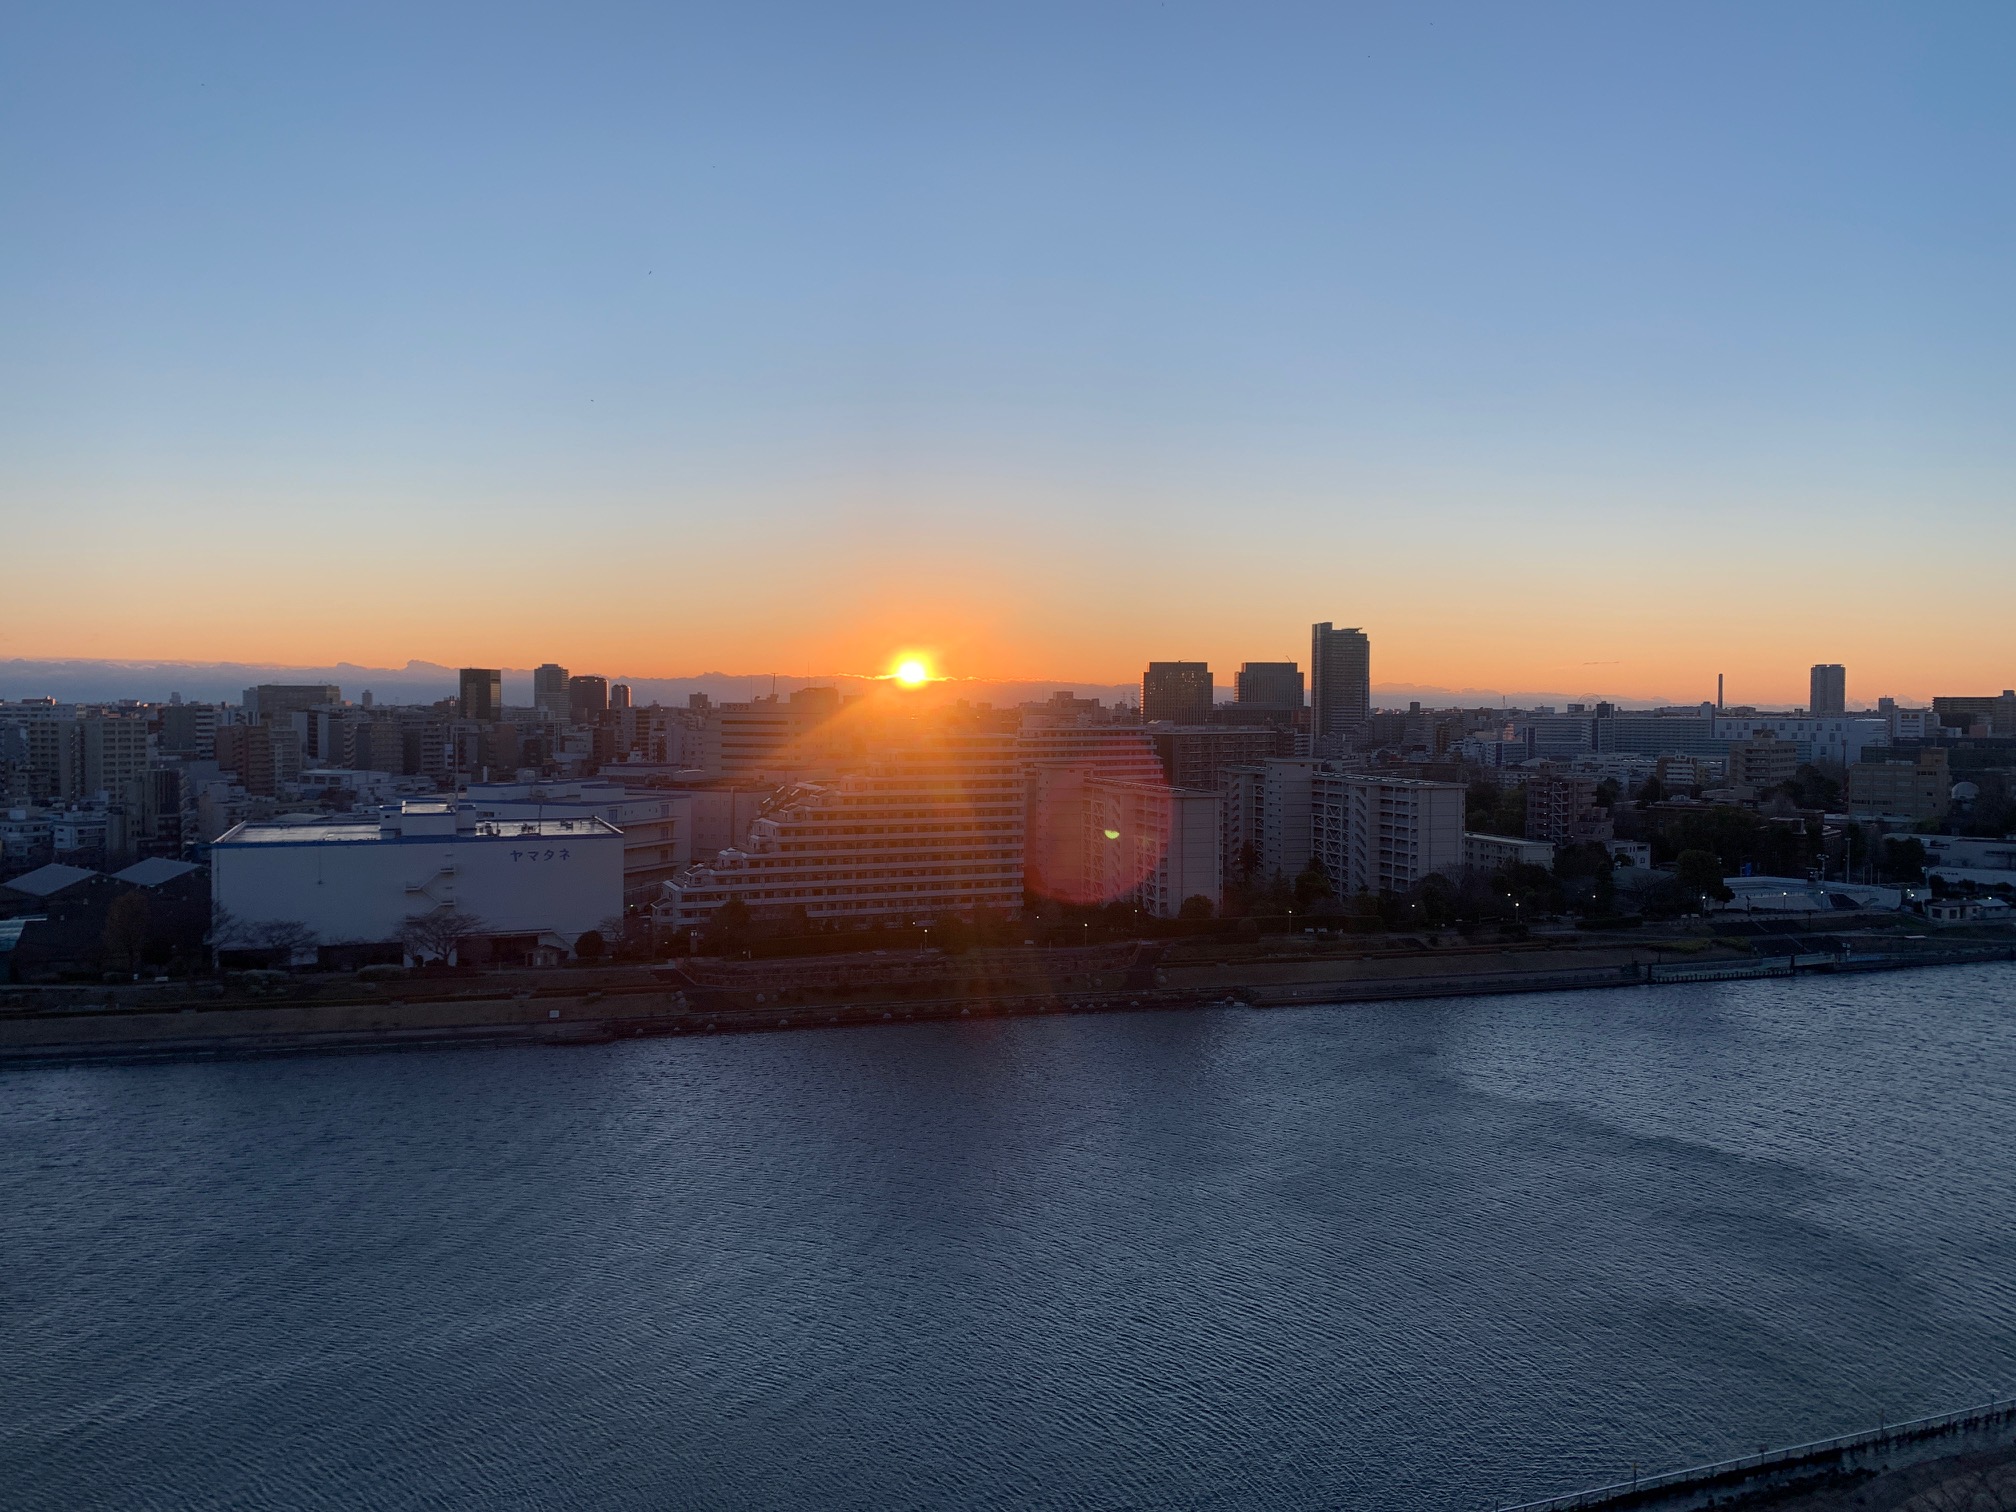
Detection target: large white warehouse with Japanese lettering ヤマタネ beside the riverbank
<box><xmin>210</xmin><ymin>800</ymin><xmax>623</xmax><ymax>954</ymax></box>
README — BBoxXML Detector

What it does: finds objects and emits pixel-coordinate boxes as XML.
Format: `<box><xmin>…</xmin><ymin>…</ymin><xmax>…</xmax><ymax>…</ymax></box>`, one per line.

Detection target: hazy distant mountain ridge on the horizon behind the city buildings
<box><xmin>0</xmin><ymin>657</ymin><xmax>1667</xmax><ymax>708</ymax></box>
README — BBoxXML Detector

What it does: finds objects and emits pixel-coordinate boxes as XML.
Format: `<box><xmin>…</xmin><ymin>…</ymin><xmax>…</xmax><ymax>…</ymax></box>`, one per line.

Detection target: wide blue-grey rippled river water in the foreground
<box><xmin>0</xmin><ymin>966</ymin><xmax>2016</xmax><ymax>1512</ymax></box>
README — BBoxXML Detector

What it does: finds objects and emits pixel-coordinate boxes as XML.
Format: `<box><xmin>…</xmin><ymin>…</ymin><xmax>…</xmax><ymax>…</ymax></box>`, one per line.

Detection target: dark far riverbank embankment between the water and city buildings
<box><xmin>0</xmin><ymin>939</ymin><xmax>2016</xmax><ymax>1060</ymax></box>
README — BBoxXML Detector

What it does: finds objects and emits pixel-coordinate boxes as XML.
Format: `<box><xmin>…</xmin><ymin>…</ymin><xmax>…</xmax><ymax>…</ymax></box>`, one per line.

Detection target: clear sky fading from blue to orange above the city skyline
<box><xmin>0</xmin><ymin>0</ymin><xmax>2016</xmax><ymax>700</ymax></box>
